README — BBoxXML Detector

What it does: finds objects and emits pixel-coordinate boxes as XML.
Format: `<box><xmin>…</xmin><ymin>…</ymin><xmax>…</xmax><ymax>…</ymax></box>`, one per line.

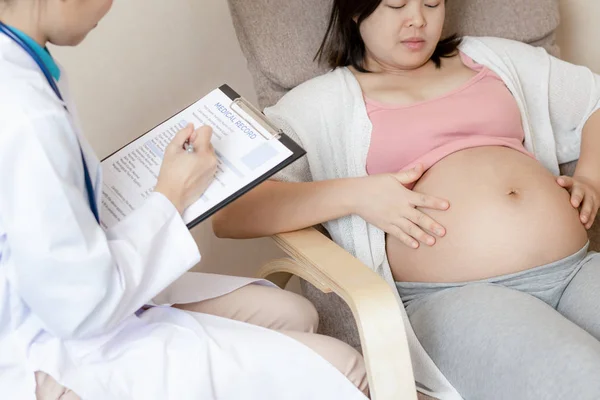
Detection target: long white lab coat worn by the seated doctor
<box><xmin>0</xmin><ymin>34</ymin><xmax>364</xmax><ymax>400</ymax></box>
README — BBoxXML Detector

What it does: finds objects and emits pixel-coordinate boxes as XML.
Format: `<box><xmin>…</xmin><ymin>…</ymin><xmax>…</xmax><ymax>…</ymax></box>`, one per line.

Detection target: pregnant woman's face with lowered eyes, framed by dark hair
<box><xmin>360</xmin><ymin>0</ymin><xmax>446</xmax><ymax>71</ymax></box>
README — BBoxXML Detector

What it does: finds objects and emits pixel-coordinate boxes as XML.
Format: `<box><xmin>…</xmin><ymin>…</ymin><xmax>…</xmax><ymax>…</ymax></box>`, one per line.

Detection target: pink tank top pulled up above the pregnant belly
<box><xmin>365</xmin><ymin>53</ymin><xmax>533</xmax><ymax>177</ymax></box>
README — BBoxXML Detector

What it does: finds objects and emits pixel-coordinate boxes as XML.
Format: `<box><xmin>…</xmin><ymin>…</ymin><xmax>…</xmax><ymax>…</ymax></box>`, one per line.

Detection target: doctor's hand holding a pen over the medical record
<box><xmin>154</xmin><ymin>124</ymin><xmax>217</xmax><ymax>214</ymax></box>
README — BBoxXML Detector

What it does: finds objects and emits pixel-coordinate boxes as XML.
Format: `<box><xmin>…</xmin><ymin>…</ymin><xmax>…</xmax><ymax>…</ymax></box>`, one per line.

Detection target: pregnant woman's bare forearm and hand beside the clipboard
<box><xmin>213</xmin><ymin>166</ymin><xmax>449</xmax><ymax>248</ymax></box>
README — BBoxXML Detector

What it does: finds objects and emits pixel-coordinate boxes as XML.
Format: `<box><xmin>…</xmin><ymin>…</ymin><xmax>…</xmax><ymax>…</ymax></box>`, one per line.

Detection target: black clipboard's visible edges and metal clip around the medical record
<box><xmin>102</xmin><ymin>84</ymin><xmax>306</xmax><ymax>229</ymax></box>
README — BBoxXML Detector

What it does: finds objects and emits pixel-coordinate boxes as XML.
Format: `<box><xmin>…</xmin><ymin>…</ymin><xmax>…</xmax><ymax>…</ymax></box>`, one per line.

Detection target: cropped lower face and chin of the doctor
<box><xmin>42</xmin><ymin>0</ymin><xmax>113</xmax><ymax>46</ymax></box>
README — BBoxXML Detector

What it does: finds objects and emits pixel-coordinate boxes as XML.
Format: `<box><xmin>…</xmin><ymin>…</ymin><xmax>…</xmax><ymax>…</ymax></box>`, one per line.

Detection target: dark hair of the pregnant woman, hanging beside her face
<box><xmin>315</xmin><ymin>0</ymin><xmax>461</xmax><ymax>72</ymax></box>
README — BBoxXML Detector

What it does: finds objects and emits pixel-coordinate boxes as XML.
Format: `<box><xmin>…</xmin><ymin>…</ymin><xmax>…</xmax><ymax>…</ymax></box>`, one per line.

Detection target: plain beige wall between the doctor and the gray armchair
<box><xmin>52</xmin><ymin>0</ymin><xmax>282</xmax><ymax>276</ymax></box>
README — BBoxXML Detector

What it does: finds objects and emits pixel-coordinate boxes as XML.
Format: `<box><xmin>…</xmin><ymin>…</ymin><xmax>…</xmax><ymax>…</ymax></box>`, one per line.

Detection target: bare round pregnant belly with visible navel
<box><xmin>386</xmin><ymin>147</ymin><xmax>587</xmax><ymax>282</ymax></box>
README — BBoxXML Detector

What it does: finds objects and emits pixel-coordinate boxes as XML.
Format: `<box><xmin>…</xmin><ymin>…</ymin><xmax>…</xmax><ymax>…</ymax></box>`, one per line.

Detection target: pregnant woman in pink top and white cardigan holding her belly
<box><xmin>214</xmin><ymin>0</ymin><xmax>600</xmax><ymax>400</ymax></box>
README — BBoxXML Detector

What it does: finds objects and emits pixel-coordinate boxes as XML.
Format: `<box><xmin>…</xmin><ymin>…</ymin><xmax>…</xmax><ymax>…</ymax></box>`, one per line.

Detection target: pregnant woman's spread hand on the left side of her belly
<box><xmin>355</xmin><ymin>165</ymin><xmax>450</xmax><ymax>248</ymax></box>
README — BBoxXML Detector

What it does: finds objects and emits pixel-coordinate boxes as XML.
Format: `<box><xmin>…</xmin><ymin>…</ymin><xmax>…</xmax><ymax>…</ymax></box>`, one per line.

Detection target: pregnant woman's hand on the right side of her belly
<box><xmin>556</xmin><ymin>176</ymin><xmax>600</xmax><ymax>229</ymax></box>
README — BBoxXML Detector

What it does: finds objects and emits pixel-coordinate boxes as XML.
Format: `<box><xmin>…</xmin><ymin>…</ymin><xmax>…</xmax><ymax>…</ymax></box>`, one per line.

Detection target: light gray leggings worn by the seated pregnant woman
<box><xmin>396</xmin><ymin>245</ymin><xmax>600</xmax><ymax>400</ymax></box>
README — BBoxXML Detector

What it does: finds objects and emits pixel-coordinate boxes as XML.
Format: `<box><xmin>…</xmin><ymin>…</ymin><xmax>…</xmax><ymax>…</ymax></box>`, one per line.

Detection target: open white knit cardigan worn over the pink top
<box><xmin>265</xmin><ymin>37</ymin><xmax>600</xmax><ymax>400</ymax></box>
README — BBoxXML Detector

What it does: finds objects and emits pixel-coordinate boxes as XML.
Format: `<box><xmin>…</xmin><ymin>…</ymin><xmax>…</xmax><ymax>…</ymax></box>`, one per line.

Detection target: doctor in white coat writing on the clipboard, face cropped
<box><xmin>0</xmin><ymin>0</ymin><xmax>366</xmax><ymax>400</ymax></box>
